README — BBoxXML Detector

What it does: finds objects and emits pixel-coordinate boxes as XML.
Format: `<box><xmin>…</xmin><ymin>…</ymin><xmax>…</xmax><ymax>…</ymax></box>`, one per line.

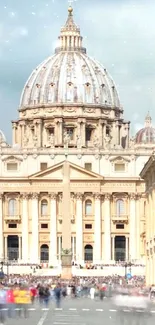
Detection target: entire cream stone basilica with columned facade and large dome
<box><xmin>0</xmin><ymin>7</ymin><xmax>155</xmax><ymax>266</ymax></box>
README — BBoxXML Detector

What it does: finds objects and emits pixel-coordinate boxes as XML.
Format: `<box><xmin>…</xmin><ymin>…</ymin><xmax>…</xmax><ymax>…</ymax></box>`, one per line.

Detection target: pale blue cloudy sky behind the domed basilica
<box><xmin>0</xmin><ymin>0</ymin><xmax>155</xmax><ymax>142</ymax></box>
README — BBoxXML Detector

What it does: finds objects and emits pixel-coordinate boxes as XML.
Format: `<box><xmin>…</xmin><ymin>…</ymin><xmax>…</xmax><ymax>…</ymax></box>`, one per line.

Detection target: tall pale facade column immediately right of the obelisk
<box><xmin>76</xmin><ymin>193</ymin><xmax>83</xmax><ymax>263</ymax></box>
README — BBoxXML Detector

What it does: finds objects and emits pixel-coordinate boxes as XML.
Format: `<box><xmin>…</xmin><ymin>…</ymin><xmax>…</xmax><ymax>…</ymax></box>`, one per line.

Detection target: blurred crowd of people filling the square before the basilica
<box><xmin>0</xmin><ymin>274</ymin><xmax>148</xmax><ymax>324</ymax></box>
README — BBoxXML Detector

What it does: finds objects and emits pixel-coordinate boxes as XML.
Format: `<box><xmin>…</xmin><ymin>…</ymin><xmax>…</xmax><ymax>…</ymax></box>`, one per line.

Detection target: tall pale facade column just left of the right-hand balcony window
<box><xmin>104</xmin><ymin>194</ymin><xmax>111</xmax><ymax>262</ymax></box>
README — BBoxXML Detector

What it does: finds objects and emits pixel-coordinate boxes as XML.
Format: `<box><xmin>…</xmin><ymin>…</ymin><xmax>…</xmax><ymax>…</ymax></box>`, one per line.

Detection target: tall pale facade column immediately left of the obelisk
<box><xmin>49</xmin><ymin>193</ymin><xmax>57</xmax><ymax>266</ymax></box>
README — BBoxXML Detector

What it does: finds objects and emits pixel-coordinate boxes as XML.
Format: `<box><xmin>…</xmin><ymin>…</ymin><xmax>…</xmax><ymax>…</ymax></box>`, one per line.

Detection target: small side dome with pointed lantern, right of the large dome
<box><xmin>135</xmin><ymin>113</ymin><xmax>155</xmax><ymax>144</ymax></box>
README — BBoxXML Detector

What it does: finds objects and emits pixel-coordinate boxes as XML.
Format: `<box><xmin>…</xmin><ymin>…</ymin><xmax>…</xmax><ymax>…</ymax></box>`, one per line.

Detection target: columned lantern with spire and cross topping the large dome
<box><xmin>55</xmin><ymin>4</ymin><xmax>86</xmax><ymax>54</ymax></box>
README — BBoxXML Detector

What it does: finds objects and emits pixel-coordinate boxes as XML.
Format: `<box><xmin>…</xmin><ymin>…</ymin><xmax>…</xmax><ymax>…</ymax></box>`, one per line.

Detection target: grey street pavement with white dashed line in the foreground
<box><xmin>6</xmin><ymin>298</ymin><xmax>155</xmax><ymax>325</ymax></box>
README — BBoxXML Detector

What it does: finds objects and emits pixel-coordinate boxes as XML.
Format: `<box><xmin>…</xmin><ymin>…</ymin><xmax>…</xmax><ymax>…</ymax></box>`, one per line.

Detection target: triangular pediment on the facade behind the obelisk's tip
<box><xmin>29</xmin><ymin>161</ymin><xmax>103</xmax><ymax>181</ymax></box>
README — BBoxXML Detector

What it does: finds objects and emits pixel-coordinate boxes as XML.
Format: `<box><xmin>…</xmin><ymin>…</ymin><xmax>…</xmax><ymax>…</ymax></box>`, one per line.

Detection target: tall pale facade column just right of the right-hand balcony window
<box><xmin>129</xmin><ymin>193</ymin><xmax>137</xmax><ymax>260</ymax></box>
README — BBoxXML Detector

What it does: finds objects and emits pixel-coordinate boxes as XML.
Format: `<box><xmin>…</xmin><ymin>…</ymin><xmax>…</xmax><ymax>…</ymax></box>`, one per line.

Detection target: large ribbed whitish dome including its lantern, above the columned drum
<box><xmin>20</xmin><ymin>8</ymin><xmax>120</xmax><ymax>109</ymax></box>
